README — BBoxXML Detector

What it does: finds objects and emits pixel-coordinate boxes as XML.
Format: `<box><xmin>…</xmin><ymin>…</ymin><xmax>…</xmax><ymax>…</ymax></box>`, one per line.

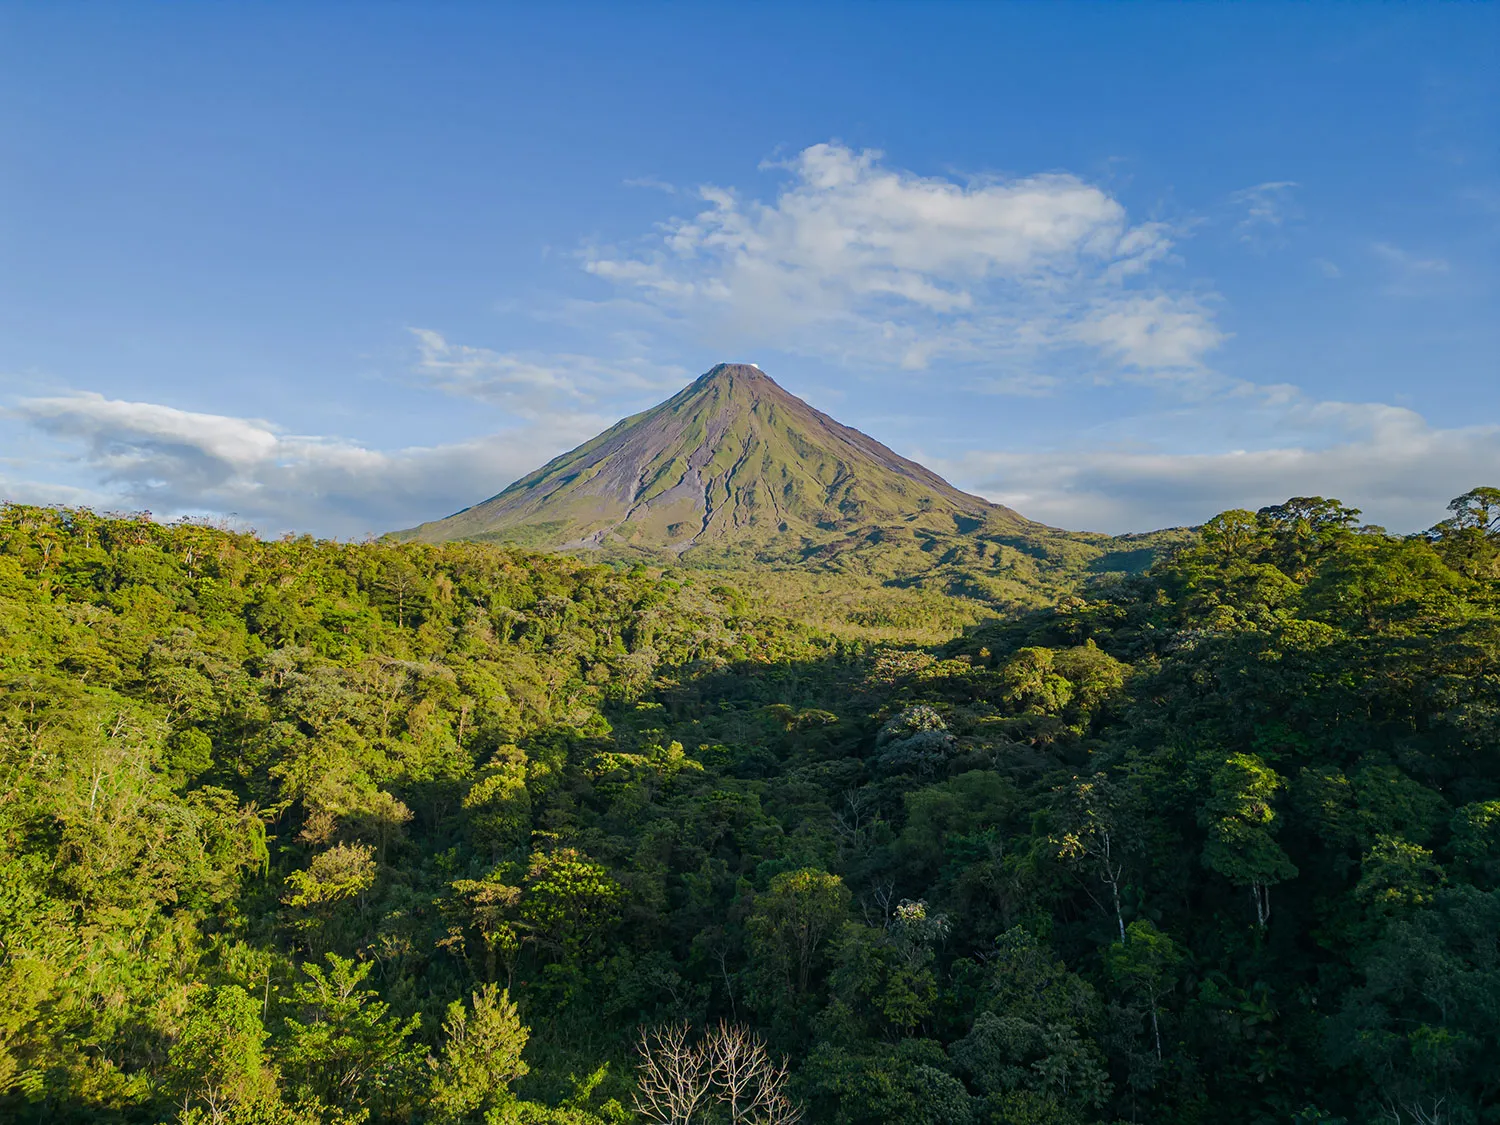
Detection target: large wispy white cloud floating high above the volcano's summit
<box><xmin>585</xmin><ymin>144</ymin><xmax>1223</xmax><ymax>371</ymax></box>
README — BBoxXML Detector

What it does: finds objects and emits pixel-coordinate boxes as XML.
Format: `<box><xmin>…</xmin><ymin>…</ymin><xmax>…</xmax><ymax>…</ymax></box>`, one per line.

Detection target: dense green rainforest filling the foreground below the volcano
<box><xmin>0</xmin><ymin>489</ymin><xmax>1500</xmax><ymax>1125</ymax></box>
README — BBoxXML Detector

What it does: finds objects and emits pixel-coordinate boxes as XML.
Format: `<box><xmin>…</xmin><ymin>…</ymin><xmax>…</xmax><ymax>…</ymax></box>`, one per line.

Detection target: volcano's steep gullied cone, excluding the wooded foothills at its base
<box><xmin>401</xmin><ymin>363</ymin><xmax>1040</xmax><ymax>561</ymax></box>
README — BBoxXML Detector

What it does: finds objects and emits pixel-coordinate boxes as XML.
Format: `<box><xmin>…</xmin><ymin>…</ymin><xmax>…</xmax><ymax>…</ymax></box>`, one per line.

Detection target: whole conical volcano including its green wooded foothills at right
<box><xmin>395</xmin><ymin>363</ymin><xmax>1188</xmax><ymax>618</ymax></box>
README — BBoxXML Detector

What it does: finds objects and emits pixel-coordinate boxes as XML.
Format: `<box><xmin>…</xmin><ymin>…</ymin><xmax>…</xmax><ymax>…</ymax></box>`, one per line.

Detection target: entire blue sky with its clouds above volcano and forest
<box><xmin>0</xmin><ymin>3</ymin><xmax>1500</xmax><ymax>536</ymax></box>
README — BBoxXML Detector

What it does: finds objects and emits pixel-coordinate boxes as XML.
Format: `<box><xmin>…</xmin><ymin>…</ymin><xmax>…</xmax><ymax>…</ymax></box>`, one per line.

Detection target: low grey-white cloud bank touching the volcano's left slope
<box><xmin>10</xmin><ymin>392</ymin><xmax>614</xmax><ymax>536</ymax></box>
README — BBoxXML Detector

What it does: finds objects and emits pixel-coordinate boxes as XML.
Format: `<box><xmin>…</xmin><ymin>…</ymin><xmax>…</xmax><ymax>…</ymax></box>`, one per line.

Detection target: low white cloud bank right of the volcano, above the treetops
<box><xmin>935</xmin><ymin>389</ymin><xmax>1500</xmax><ymax>533</ymax></box>
